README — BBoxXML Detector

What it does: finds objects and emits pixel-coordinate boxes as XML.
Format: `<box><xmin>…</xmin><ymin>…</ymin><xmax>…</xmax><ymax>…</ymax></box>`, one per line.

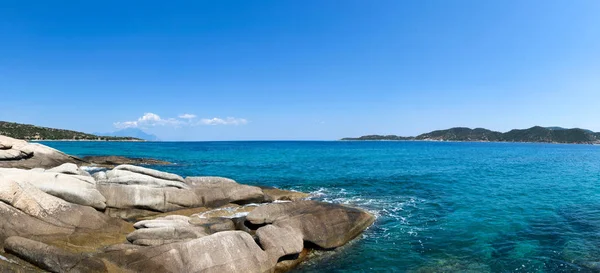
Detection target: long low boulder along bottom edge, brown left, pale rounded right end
<box><xmin>5</xmin><ymin>231</ymin><xmax>277</xmax><ymax>273</ymax></box>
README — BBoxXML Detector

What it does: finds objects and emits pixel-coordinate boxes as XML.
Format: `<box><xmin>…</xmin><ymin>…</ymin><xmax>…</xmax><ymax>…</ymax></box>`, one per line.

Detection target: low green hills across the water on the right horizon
<box><xmin>342</xmin><ymin>126</ymin><xmax>600</xmax><ymax>144</ymax></box>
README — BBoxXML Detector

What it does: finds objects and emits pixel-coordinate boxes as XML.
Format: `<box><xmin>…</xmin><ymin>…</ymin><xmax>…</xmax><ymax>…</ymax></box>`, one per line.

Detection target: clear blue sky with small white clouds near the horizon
<box><xmin>0</xmin><ymin>0</ymin><xmax>600</xmax><ymax>140</ymax></box>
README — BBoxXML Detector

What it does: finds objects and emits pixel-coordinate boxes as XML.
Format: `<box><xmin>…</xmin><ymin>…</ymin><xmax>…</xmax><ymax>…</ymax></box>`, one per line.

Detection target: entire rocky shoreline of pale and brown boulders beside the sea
<box><xmin>0</xmin><ymin>136</ymin><xmax>375</xmax><ymax>272</ymax></box>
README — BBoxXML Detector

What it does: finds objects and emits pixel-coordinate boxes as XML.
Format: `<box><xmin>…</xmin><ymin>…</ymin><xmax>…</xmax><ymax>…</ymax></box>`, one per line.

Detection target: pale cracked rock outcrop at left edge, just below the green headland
<box><xmin>0</xmin><ymin>135</ymin><xmax>82</xmax><ymax>169</ymax></box>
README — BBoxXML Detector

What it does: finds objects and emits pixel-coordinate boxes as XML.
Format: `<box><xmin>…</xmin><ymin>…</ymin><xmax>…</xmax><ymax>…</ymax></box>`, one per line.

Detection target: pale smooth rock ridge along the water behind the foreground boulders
<box><xmin>99</xmin><ymin>170</ymin><xmax>264</xmax><ymax>220</ymax></box>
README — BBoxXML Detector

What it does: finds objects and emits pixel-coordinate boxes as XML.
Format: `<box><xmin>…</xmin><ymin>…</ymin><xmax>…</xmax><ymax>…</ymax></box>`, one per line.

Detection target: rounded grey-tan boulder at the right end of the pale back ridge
<box><xmin>185</xmin><ymin>176</ymin><xmax>265</xmax><ymax>207</ymax></box>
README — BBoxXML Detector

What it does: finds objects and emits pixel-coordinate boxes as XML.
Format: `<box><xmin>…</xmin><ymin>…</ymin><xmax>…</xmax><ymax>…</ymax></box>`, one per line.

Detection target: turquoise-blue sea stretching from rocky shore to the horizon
<box><xmin>39</xmin><ymin>142</ymin><xmax>600</xmax><ymax>272</ymax></box>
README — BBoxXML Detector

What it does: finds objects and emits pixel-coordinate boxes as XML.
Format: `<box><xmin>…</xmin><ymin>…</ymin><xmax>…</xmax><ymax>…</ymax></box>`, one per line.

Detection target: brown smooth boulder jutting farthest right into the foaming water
<box><xmin>246</xmin><ymin>201</ymin><xmax>375</xmax><ymax>249</ymax></box>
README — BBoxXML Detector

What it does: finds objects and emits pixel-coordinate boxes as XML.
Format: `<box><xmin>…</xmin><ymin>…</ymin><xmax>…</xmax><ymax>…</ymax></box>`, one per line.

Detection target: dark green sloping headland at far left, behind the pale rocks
<box><xmin>0</xmin><ymin>121</ymin><xmax>141</xmax><ymax>141</ymax></box>
